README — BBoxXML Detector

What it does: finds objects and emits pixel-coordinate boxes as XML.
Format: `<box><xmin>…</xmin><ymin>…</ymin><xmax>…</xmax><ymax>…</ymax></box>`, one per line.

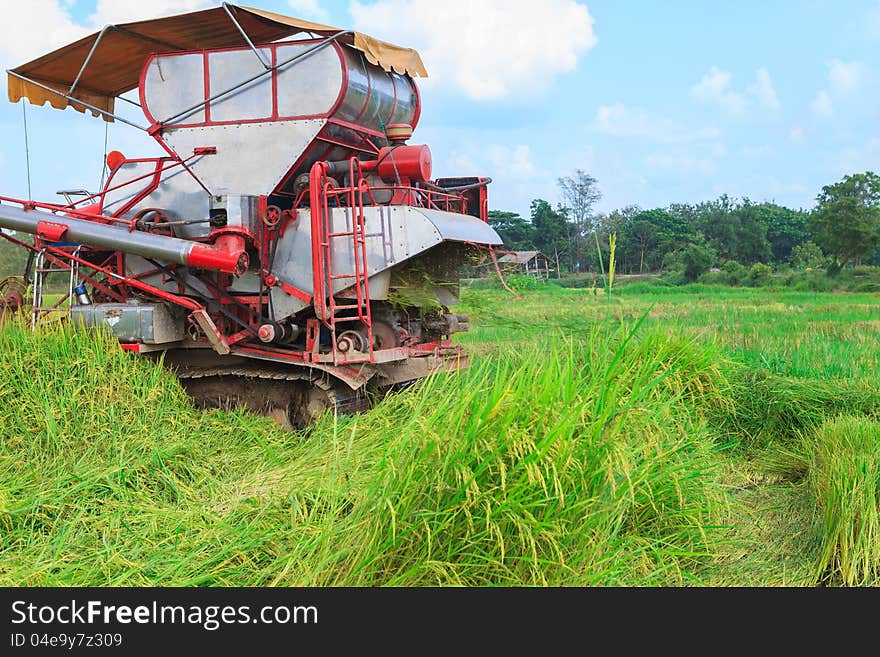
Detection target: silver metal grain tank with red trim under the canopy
<box><xmin>140</xmin><ymin>39</ymin><xmax>420</xmax><ymax>211</ymax></box>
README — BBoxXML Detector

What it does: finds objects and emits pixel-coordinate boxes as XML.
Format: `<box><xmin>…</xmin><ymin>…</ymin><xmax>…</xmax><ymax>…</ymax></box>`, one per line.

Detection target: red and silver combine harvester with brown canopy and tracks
<box><xmin>0</xmin><ymin>4</ymin><xmax>501</xmax><ymax>427</ymax></box>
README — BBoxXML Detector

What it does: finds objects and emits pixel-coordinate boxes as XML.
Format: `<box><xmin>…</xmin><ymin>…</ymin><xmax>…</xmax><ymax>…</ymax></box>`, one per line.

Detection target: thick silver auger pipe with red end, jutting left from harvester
<box><xmin>0</xmin><ymin>205</ymin><xmax>248</xmax><ymax>276</ymax></box>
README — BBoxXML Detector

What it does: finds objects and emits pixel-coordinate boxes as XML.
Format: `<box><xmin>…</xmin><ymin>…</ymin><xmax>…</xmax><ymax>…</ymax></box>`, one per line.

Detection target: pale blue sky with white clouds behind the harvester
<box><xmin>0</xmin><ymin>0</ymin><xmax>880</xmax><ymax>216</ymax></box>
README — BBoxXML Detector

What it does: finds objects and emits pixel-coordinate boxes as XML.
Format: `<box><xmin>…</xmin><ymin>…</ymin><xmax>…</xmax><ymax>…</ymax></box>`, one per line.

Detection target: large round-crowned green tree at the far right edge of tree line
<box><xmin>811</xmin><ymin>171</ymin><xmax>880</xmax><ymax>271</ymax></box>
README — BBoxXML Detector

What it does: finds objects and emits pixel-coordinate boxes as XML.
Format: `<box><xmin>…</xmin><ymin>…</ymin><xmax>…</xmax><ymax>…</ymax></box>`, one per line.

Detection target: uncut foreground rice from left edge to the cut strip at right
<box><xmin>0</xmin><ymin>318</ymin><xmax>726</xmax><ymax>586</ymax></box>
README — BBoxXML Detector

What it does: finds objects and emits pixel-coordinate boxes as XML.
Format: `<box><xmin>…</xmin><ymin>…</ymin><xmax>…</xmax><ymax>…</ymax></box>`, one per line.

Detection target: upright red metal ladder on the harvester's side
<box><xmin>309</xmin><ymin>158</ymin><xmax>375</xmax><ymax>365</ymax></box>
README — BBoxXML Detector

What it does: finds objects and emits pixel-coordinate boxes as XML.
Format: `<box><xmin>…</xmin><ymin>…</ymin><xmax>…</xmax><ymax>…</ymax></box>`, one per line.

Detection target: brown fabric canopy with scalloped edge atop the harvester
<box><xmin>7</xmin><ymin>4</ymin><xmax>428</xmax><ymax>120</ymax></box>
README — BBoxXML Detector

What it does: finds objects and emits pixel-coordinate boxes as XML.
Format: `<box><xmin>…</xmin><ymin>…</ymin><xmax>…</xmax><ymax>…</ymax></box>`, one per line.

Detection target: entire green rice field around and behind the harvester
<box><xmin>0</xmin><ymin>284</ymin><xmax>880</xmax><ymax>586</ymax></box>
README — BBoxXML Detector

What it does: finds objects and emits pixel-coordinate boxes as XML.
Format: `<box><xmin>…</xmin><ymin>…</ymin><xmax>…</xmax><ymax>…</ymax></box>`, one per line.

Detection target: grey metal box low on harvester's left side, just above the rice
<box><xmin>70</xmin><ymin>303</ymin><xmax>184</xmax><ymax>344</ymax></box>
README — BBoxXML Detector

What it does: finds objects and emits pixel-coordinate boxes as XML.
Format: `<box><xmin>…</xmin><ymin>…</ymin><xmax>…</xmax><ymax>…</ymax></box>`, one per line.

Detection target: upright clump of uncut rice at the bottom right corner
<box><xmin>809</xmin><ymin>415</ymin><xmax>880</xmax><ymax>586</ymax></box>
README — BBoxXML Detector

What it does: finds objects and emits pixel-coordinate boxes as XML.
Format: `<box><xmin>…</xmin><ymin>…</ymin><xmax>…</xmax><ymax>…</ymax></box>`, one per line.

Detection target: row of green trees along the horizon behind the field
<box><xmin>489</xmin><ymin>170</ymin><xmax>880</xmax><ymax>280</ymax></box>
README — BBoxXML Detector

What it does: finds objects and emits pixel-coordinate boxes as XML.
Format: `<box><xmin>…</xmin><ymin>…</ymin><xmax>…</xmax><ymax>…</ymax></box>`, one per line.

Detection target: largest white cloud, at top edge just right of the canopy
<box><xmin>349</xmin><ymin>0</ymin><xmax>596</xmax><ymax>100</ymax></box>
